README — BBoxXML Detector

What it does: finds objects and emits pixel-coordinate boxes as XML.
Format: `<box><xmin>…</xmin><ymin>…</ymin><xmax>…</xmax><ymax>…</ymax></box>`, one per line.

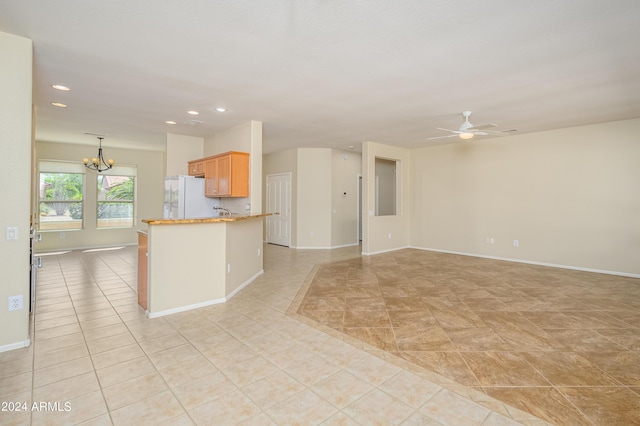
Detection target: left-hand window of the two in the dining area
<box><xmin>38</xmin><ymin>162</ymin><xmax>84</xmax><ymax>231</ymax></box>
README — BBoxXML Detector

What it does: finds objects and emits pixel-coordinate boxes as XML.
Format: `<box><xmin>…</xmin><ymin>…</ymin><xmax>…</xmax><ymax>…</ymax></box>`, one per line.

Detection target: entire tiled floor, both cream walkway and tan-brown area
<box><xmin>0</xmin><ymin>245</ymin><xmax>640</xmax><ymax>425</ymax></box>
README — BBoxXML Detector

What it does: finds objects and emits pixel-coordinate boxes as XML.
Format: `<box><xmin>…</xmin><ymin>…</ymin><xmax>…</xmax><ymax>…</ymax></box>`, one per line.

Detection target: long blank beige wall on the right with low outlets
<box><xmin>411</xmin><ymin>119</ymin><xmax>640</xmax><ymax>274</ymax></box>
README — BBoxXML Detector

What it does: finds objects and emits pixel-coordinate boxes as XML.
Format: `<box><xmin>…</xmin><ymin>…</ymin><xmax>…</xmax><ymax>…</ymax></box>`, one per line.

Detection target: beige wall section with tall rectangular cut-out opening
<box><xmin>362</xmin><ymin>142</ymin><xmax>413</xmax><ymax>254</ymax></box>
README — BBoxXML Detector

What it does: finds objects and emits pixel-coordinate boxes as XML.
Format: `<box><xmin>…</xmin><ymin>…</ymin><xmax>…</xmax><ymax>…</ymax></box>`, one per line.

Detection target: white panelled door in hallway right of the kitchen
<box><xmin>267</xmin><ymin>173</ymin><xmax>291</xmax><ymax>247</ymax></box>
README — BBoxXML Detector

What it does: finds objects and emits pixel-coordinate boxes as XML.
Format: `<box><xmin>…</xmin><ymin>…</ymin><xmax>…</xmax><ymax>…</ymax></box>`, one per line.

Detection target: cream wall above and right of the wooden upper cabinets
<box><xmin>204</xmin><ymin>121</ymin><xmax>262</xmax><ymax>214</ymax></box>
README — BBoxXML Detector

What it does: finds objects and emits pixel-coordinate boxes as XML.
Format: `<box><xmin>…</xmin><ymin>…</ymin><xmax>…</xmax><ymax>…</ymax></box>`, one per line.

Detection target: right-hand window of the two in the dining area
<box><xmin>97</xmin><ymin>174</ymin><xmax>135</xmax><ymax>228</ymax></box>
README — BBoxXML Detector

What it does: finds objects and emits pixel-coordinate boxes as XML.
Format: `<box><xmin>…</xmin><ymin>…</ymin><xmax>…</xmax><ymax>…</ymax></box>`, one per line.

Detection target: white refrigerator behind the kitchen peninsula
<box><xmin>164</xmin><ymin>176</ymin><xmax>220</xmax><ymax>219</ymax></box>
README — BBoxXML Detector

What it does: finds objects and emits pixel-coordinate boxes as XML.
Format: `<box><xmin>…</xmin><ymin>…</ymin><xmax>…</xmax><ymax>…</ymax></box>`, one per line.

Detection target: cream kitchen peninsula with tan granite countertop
<box><xmin>138</xmin><ymin>214</ymin><xmax>268</xmax><ymax>318</ymax></box>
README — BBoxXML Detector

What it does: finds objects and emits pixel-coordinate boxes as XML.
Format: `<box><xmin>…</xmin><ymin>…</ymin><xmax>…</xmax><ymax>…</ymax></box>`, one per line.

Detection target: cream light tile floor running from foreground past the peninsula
<box><xmin>0</xmin><ymin>246</ymin><xmax>552</xmax><ymax>425</ymax></box>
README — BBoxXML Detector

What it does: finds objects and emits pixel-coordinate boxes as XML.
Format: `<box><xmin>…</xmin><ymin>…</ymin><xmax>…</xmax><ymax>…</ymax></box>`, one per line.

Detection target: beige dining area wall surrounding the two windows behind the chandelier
<box><xmin>34</xmin><ymin>141</ymin><xmax>165</xmax><ymax>252</ymax></box>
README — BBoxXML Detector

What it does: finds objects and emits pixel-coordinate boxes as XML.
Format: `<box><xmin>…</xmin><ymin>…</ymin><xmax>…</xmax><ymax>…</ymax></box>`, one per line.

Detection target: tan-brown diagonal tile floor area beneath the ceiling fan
<box><xmin>296</xmin><ymin>249</ymin><xmax>640</xmax><ymax>425</ymax></box>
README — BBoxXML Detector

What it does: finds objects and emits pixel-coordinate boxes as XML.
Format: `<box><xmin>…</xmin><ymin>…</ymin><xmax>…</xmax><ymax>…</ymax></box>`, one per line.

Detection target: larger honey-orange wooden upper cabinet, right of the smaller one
<box><xmin>203</xmin><ymin>151</ymin><xmax>249</xmax><ymax>197</ymax></box>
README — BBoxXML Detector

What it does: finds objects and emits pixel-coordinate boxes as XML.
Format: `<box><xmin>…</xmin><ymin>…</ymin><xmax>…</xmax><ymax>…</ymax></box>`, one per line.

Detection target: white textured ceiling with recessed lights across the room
<box><xmin>0</xmin><ymin>0</ymin><xmax>640</xmax><ymax>152</ymax></box>
